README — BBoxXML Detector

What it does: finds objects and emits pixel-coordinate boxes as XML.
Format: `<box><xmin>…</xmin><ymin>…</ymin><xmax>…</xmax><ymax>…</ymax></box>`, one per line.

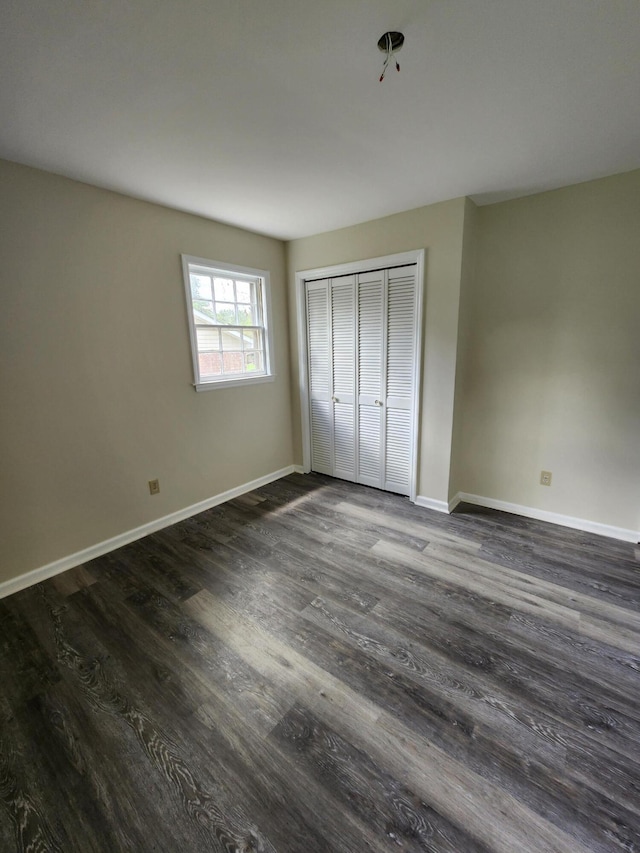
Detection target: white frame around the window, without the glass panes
<box><xmin>181</xmin><ymin>255</ymin><xmax>275</xmax><ymax>391</ymax></box>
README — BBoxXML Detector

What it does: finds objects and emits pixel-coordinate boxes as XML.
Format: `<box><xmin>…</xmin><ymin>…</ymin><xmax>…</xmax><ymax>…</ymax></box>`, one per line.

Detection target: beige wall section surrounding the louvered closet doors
<box><xmin>288</xmin><ymin>199</ymin><xmax>465</xmax><ymax>501</ymax></box>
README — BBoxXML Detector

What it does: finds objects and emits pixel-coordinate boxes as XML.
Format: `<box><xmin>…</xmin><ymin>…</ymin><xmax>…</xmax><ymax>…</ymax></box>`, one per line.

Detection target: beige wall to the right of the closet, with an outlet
<box><xmin>456</xmin><ymin>171</ymin><xmax>640</xmax><ymax>530</ymax></box>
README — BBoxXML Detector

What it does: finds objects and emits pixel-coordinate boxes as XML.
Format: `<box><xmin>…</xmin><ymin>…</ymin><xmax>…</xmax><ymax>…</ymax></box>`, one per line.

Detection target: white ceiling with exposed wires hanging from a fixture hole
<box><xmin>0</xmin><ymin>0</ymin><xmax>640</xmax><ymax>239</ymax></box>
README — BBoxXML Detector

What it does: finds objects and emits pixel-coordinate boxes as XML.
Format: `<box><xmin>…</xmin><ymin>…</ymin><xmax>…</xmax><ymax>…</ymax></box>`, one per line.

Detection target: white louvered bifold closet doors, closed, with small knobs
<box><xmin>306</xmin><ymin>265</ymin><xmax>416</xmax><ymax>495</ymax></box>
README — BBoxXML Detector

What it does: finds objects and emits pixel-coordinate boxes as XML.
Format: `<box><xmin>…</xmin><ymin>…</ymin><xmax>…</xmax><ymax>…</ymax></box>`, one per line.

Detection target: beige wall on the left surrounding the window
<box><xmin>0</xmin><ymin>161</ymin><xmax>293</xmax><ymax>581</ymax></box>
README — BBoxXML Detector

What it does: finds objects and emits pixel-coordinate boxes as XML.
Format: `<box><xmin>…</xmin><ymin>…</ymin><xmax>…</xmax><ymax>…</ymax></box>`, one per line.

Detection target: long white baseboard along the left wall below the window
<box><xmin>0</xmin><ymin>465</ymin><xmax>297</xmax><ymax>598</ymax></box>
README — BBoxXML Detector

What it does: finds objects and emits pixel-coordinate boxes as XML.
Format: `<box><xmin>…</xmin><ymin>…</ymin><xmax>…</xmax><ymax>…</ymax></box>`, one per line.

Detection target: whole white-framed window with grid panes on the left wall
<box><xmin>182</xmin><ymin>255</ymin><xmax>273</xmax><ymax>391</ymax></box>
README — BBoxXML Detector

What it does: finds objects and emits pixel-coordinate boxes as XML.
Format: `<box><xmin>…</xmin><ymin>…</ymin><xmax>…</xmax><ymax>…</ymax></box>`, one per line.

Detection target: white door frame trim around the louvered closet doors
<box><xmin>295</xmin><ymin>249</ymin><xmax>425</xmax><ymax>503</ymax></box>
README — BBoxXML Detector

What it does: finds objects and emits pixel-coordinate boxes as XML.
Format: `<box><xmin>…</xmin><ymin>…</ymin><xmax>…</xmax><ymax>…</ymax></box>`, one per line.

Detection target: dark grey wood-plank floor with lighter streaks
<box><xmin>0</xmin><ymin>475</ymin><xmax>640</xmax><ymax>853</ymax></box>
